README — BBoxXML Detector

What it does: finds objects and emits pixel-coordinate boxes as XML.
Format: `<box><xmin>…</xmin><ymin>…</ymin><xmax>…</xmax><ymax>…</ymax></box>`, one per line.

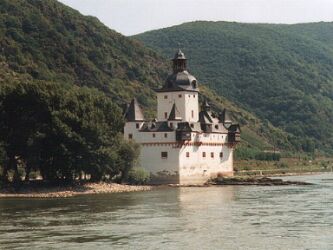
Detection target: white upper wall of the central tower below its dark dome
<box><xmin>157</xmin><ymin>91</ymin><xmax>199</xmax><ymax>122</ymax></box>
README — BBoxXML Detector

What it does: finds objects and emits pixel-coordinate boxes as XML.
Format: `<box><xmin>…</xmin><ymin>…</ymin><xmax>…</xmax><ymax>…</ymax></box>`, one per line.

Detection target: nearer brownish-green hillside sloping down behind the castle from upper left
<box><xmin>0</xmin><ymin>0</ymin><xmax>294</xmax><ymax>156</ymax></box>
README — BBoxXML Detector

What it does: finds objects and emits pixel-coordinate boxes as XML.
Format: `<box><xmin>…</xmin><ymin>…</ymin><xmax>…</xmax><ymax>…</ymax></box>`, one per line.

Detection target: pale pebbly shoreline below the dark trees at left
<box><xmin>0</xmin><ymin>182</ymin><xmax>153</xmax><ymax>199</ymax></box>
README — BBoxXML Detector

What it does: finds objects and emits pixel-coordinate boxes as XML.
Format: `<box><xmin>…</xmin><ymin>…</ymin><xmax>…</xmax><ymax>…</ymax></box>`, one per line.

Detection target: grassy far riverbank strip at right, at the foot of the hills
<box><xmin>234</xmin><ymin>158</ymin><xmax>333</xmax><ymax>176</ymax></box>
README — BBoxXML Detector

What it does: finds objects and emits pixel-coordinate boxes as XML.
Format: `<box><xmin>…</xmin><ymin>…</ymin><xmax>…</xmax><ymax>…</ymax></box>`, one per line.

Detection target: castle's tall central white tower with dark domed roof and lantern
<box><xmin>156</xmin><ymin>50</ymin><xmax>199</xmax><ymax>122</ymax></box>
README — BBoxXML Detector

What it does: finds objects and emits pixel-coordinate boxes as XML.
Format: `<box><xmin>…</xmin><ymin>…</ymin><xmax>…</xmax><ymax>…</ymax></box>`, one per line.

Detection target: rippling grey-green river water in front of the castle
<box><xmin>0</xmin><ymin>174</ymin><xmax>333</xmax><ymax>250</ymax></box>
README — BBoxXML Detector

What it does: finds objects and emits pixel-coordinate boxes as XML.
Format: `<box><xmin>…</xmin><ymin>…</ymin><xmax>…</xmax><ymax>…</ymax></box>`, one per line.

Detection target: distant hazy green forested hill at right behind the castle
<box><xmin>134</xmin><ymin>22</ymin><xmax>333</xmax><ymax>153</ymax></box>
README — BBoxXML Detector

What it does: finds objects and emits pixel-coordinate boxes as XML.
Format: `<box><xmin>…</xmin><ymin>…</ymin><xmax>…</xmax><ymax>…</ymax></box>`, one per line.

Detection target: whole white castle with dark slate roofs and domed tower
<box><xmin>124</xmin><ymin>50</ymin><xmax>240</xmax><ymax>185</ymax></box>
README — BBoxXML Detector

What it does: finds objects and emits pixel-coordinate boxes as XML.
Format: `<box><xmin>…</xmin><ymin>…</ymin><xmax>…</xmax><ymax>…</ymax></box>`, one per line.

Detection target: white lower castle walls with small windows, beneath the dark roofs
<box><xmin>124</xmin><ymin>122</ymin><xmax>233</xmax><ymax>184</ymax></box>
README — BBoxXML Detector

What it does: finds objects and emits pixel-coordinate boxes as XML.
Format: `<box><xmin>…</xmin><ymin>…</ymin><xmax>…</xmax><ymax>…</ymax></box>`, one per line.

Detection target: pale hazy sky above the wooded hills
<box><xmin>60</xmin><ymin>0</ymin><xmax>333</xmax><ymax>35</ymax></box>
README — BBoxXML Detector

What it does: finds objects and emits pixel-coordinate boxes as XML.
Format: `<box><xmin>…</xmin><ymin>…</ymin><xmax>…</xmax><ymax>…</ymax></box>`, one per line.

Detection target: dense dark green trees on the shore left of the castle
<box><xmin>0</xmin><ymin>81</ymin><xmax>139</xmax><ymax>185</ymax></box>
